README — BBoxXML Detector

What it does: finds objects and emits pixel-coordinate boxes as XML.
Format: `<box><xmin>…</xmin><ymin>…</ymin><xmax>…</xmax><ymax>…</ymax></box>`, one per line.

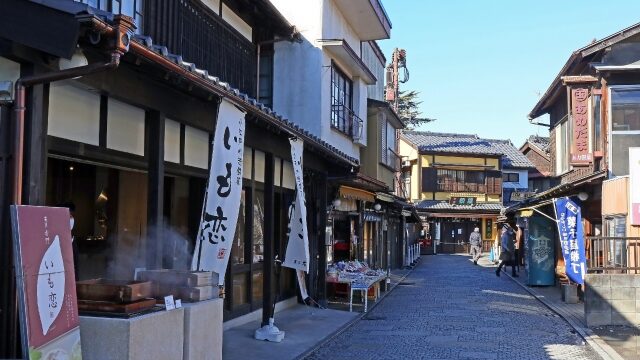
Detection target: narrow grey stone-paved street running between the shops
<box><xmin>307</xmin><ymin>255</ymin><xmax>600</xmax><ymax>360</ymax></box>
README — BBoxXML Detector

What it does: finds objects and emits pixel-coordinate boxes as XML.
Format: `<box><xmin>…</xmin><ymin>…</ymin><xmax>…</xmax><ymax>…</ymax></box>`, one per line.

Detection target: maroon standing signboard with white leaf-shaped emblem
<box><xmin>11</xmin><ymin>206</ymin><xmax>82</xmax><ymax>359</ymax></box>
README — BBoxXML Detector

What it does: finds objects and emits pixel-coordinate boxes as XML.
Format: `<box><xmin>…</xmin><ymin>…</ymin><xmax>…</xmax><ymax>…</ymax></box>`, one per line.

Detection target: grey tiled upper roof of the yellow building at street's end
<box><xmin>403</xmin><ymin>131</ymin><xmax>534</xmax><ymax>168</ymax></box>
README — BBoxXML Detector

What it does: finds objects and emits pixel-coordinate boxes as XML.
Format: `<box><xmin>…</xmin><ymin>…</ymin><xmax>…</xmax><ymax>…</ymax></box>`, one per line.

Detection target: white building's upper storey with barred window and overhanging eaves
<box><xmin>272</xmin><ymin>0</ymin><xmax>391</xmax><ymax>159</ymax></box>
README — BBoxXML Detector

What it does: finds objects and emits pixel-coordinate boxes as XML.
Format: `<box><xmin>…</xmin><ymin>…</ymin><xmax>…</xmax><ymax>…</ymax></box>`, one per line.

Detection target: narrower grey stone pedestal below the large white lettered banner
<box><xmin>182</xmin><ymin>298</ymin><xmax>224</xmax><ymax>360</ymax></box>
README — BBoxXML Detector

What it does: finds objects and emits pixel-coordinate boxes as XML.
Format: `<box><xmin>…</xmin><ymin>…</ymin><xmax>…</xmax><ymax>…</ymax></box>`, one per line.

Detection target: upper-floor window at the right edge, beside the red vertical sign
<box><xmin>609</xmin><ymin>86</ymin><xmax>640</xmax><ymax>176</ymax></box>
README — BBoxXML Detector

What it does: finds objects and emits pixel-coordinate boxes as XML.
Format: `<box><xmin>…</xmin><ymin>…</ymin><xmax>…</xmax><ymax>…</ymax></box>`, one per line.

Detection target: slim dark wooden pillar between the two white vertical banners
<box><xmin>262</xmin><ymin>153</ymin><xmax>278</xmax><ymax>326</ymax></box>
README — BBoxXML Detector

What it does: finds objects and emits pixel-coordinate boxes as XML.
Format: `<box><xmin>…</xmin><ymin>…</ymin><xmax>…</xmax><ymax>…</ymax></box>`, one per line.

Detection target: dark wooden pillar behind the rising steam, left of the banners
<box><xmin>146</xmin><ymin>110</ymin><xmax>164</xmax><ymax>269</ymax></box>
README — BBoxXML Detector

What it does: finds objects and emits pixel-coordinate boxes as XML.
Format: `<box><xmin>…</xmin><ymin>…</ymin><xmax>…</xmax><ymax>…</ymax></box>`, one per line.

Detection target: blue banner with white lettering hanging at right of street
<box><xmin>554</xmin><ymin>198</ymin><xmax>587</xmax><ymax>284</ymax></box>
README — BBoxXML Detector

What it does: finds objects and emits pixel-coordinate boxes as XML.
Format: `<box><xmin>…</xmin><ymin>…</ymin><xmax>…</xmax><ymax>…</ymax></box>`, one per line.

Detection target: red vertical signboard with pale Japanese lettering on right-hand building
<box><xmin>571</xmin><ymin>87</ymin><xmax>593</xmax><ymax>165</ymax></box>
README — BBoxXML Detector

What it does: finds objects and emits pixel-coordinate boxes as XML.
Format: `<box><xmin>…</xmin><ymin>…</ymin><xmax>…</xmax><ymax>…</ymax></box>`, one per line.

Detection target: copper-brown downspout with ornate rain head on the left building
<box><xmin>13</xmin><ymin>15</ymin><xmax>135</xmax><ymax>205</ymax></box>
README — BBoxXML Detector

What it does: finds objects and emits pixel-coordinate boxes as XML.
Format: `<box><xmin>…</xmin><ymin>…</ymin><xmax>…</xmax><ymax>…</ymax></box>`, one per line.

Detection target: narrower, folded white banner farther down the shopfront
<box><xmin>282</xmin><ymin>138</ymin><xmax>309</xmax><ymax>272</ymax></box>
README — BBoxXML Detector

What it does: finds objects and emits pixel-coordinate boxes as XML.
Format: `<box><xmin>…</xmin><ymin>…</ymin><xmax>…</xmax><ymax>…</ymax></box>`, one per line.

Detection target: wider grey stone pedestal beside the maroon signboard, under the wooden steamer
<box><xmin>80</xmin><ymin>309</ymin><xmax>184</xmax><ymax>360</ymax></box>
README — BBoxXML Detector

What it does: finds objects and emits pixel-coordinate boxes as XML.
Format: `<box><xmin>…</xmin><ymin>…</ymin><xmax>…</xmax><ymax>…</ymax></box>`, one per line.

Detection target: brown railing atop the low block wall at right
<box><xmin>585</xmin><ymin>237</ymin><xmax>640</xmax><ymax>274</ymax></box>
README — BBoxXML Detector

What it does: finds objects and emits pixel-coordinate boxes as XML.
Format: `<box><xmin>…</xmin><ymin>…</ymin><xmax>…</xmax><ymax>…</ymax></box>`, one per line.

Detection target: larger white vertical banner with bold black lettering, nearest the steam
<box><xmin>191</xmin><ymin>99</ymin><xmax>245</xmax><ymax>285</ymax></box>
